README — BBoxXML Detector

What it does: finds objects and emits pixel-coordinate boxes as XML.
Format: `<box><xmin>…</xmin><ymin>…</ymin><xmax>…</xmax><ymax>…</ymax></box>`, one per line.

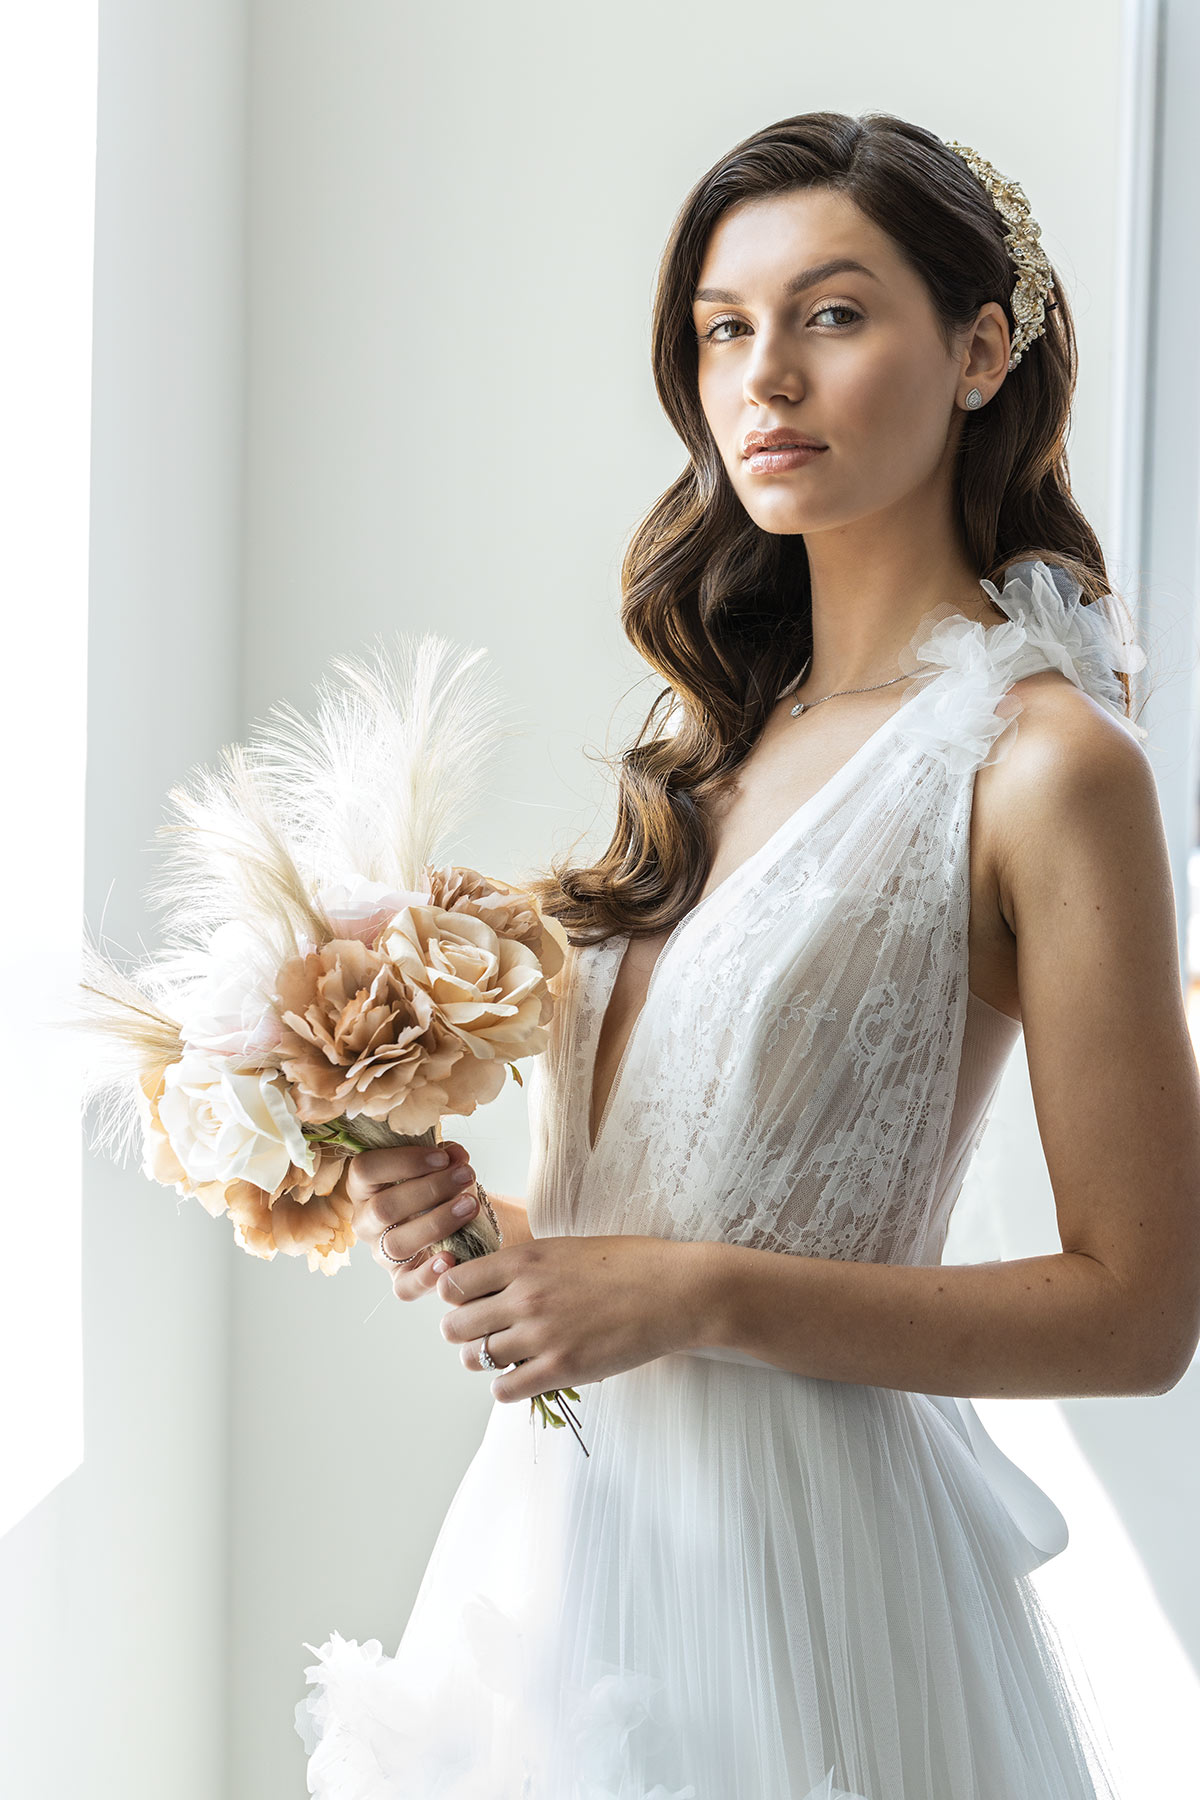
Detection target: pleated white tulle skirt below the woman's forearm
<box><xmin>295</xmin><ymin>1352</ymin><xmax>1117</xmax><ymax>1800</ymax></box>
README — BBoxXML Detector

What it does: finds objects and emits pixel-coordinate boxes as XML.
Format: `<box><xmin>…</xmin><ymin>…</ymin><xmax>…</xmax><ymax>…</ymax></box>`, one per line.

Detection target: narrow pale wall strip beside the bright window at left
<box><xmin>0</xmin><ymin>0</ymin><xmax>245</xmax><ymax>1800</ymax></box>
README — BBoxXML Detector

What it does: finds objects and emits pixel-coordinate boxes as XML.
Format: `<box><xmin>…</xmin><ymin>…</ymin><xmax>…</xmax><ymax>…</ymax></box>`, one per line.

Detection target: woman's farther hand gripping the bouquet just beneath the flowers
<box><xmin>345</xmin><ymin>1143</ymin><xmax>479</xmax><ymax>1300</ymax></box>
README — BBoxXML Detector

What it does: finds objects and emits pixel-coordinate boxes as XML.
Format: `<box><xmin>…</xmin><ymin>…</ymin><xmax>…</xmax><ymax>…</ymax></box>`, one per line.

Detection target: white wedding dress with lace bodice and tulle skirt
<box><xmin>297</xmin><ymin>562</ymin><xmax>1144</xmax><ymax>1800</ymax></box>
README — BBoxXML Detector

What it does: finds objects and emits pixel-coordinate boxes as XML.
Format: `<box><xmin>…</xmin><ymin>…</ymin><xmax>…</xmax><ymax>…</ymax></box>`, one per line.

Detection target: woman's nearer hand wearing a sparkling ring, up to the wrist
<box><xmin>433</xmin><ymin>1235</ymin><xmax>705</xmax><ymax>1400</ymax></box>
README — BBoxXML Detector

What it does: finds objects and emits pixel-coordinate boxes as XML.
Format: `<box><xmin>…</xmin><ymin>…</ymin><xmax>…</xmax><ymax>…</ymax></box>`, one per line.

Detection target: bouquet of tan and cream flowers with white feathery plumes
<box><xmin>74</xmin><ymin>635</ymin><xmax>579</xmax><ymax>1435</ymax></box>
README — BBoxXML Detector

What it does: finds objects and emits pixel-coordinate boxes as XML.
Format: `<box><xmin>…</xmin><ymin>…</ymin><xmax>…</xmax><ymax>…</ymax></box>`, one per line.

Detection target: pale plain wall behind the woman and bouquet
<box><xmin>0</xmin><ymin>0</ymin><xmax>1200</xmax><ymax>1800</ymax></box>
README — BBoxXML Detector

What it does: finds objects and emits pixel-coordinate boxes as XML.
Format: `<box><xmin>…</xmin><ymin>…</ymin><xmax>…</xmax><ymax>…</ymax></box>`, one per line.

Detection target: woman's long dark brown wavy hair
<box><xmin>525</xmin><ymin>112</ymin><xmax>1130</xmax><ymax>943</ymax></box>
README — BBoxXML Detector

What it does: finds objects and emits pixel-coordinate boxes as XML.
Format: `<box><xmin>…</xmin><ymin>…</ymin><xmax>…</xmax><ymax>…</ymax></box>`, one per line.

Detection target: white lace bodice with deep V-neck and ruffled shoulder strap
<box><xmin>529</xmin><ymin>562</ymin><xmax>1144</xmax><ymax>1262</ymax></box>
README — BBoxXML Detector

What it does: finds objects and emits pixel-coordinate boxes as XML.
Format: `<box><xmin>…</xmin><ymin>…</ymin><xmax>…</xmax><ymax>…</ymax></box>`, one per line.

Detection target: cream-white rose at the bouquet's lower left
<box><xmin>158</xmin><ymin>1049</ymin><xmax>313</xmax><ymax>1193</ymax></box>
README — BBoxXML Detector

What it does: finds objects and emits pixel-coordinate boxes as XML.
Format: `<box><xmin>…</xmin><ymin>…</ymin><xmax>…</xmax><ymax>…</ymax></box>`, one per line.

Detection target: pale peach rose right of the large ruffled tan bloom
<box><xmin>378</xmin><ymin>905</ymin><xmax>554</xmax><ymax>1108</ymax></box>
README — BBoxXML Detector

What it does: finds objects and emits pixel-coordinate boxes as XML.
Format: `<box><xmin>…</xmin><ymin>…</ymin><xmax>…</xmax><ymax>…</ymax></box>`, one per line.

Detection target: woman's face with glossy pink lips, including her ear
<box><xmin>693</xmin><ymin>187</ymin><xmax>1007</xmax><ymax>533</ymax></box>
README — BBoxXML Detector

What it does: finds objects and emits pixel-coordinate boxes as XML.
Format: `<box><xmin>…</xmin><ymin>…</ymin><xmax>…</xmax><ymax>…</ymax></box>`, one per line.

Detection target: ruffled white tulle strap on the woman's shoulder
<box><xmin>896</xmin><ymin>558</ymin><xmax>1146</xmax><ymax>772</ymax></box>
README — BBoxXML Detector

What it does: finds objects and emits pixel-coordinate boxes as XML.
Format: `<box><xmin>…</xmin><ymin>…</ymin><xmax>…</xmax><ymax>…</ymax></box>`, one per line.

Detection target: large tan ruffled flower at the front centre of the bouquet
<box><xmin>275</xmin><ymin>936</ymin><xmax>462</xmax><ymax>1136</ymax></box>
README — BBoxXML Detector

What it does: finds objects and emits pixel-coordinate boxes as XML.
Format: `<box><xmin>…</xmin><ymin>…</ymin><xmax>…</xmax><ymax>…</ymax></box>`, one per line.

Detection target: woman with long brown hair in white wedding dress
<box><xmin>297</xmin><ymin>113</ymin><xmax>1200</xmax><ymax>1800</ymax></box>
